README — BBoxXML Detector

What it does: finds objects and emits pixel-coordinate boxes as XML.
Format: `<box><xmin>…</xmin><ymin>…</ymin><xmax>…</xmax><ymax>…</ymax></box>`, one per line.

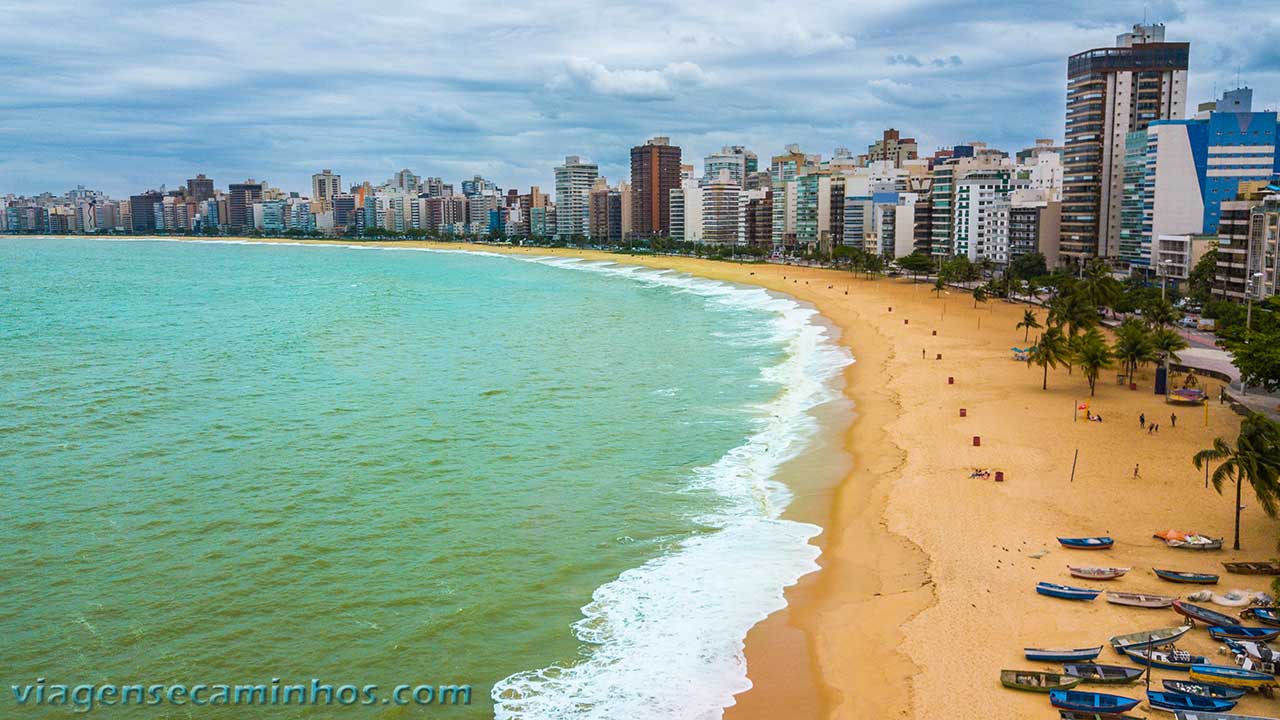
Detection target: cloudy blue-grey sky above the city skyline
<box><xmin>0</xmin><ymin>0</ymin><xmax>1280</xmax><ymax>196</ymax></box>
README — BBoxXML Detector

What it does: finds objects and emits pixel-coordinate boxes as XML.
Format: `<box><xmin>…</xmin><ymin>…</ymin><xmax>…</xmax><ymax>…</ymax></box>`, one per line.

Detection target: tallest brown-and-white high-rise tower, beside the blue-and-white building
<box><xmin>1061</xmin><ymin>24</ymin><xmax>1190</xmax><ymax>261</ymax></box>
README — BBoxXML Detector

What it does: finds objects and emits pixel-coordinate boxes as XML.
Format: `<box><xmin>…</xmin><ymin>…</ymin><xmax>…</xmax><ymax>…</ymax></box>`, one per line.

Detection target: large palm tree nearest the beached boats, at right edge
<box><xmin>1192</xmin><ymin>413</ymin><xmax>1280</xmax><ymax>550</ymax></box>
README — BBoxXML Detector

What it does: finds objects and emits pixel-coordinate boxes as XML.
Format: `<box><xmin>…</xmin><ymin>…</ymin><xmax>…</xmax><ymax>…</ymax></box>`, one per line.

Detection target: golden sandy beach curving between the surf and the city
<box><xmin>122</xmin><ymin>242</ymin><xmax>1277</xmax><ymax>720</ymax></box>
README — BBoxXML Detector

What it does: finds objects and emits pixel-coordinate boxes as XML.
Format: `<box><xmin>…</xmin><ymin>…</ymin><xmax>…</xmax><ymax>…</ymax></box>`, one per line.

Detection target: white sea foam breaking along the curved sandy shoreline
<box><xmin>64</xmin><ymin>238</ymin><xmax>852</xmax><ymax>720</ymax></box>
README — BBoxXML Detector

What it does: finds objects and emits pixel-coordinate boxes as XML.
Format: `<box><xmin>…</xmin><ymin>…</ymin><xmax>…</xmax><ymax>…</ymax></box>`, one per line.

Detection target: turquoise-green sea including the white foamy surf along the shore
<box><xmin>0</xmin><ymin>240</ymin><xmax>847</xmax><ymax>719</ymax></box>
